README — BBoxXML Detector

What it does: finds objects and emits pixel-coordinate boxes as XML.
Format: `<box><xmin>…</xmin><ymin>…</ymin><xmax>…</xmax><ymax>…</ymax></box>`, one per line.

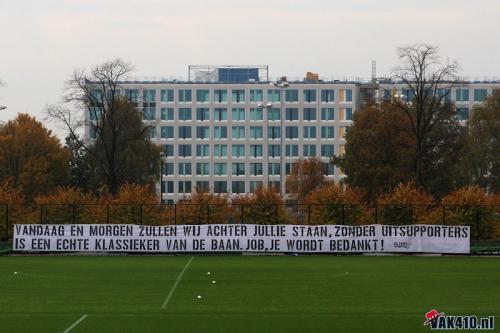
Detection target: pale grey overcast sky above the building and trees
<box><xmin>0</xmin><ymin>0</ymin><xmax>500</xmax><ymax>137</ymax></box>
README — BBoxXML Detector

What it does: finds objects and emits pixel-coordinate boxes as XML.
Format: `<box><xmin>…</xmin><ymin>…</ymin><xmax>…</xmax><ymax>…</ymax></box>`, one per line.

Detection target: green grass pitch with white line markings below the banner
<box><xmin>0</xmin><ymin>256</ymin><xmax>500</xmax><ymax>333</ymax></box>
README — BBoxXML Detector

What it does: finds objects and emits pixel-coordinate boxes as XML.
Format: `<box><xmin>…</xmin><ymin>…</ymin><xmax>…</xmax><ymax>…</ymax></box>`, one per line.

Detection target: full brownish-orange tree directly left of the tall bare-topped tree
<box><xmin>332</xmin><ymin>103</ymin><xmax>415</xmax><ymax>200</ymax></box>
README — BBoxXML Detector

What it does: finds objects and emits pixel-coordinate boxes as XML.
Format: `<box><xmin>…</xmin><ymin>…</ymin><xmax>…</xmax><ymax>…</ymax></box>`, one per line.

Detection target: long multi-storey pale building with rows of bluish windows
<box><xmin>87</xmin><ymin>66</ymin><xmax>500</xmax><ymax>202</ymax></box>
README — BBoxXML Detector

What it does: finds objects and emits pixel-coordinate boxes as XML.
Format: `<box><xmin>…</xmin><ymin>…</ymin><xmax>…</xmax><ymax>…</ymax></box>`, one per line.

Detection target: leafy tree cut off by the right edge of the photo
<box><xmin>463</xmin><ymin>93</ymin><xmax>500</xmax><ymax>193</ymax></box>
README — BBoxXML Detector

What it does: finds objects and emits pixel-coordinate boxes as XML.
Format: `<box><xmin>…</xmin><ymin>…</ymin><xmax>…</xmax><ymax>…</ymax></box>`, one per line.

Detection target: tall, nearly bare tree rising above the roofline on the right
<box><xmin>390</xmin><ymin>44</ymin><xmax>458</xmax><ymax>187</ymax></box>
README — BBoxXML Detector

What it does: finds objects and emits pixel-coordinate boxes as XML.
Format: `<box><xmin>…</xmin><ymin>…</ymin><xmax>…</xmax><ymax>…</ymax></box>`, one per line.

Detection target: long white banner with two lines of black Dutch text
<box><xmin>14</xmin><ymin>224</ymin><xmax>470</xmax><ymax>253</ymax></box>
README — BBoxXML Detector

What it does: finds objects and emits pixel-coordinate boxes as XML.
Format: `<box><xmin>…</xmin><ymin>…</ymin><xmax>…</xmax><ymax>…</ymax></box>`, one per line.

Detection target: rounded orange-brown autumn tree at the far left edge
<box><xmin>0</xmin><ymin>114</ymin><xmax>70</xmax><ymax>202</ymax></box>
